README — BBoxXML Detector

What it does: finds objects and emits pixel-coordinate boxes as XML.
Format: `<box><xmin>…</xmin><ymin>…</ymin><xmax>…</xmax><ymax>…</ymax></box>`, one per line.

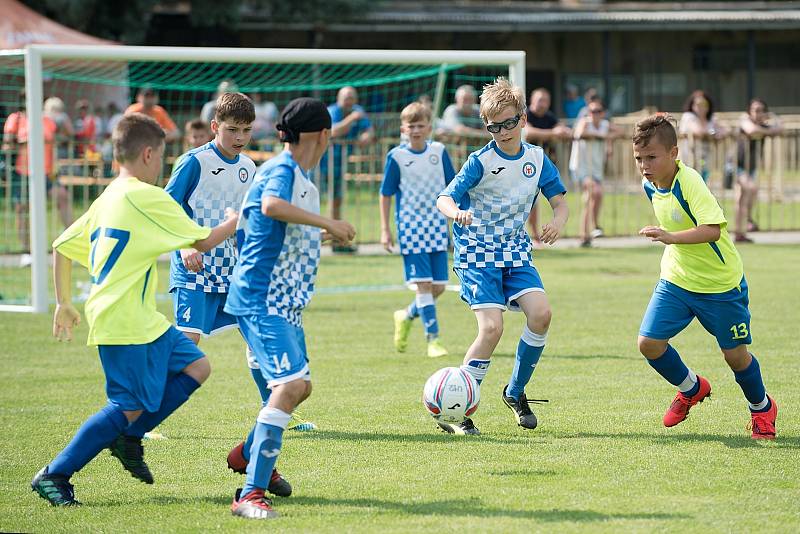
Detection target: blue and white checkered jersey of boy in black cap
<box><xmin>225</xmin><ymin>151</ymin><xmax>322</xmax><ymax>326</ymax></box>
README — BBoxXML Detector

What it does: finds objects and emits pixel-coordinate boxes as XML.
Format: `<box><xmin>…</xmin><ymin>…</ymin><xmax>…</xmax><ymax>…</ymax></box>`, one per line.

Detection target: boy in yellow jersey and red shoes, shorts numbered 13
<box><xmin>633</xmin><ymin>115</ymin><xmax>778</xmax><ymax>439</ymax></box>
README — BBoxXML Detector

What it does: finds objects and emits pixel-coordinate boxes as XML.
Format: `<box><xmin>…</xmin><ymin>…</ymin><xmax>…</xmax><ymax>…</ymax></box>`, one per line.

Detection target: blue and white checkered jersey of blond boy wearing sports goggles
<box><xmin>440</xmin><ymin>141</ymin><xmax>567</xmax><ymax>268</ymax></box>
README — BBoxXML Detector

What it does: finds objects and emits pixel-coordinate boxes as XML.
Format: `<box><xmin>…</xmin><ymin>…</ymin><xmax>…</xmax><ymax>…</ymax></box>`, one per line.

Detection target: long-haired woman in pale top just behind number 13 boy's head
<box><xmin>678</xmin><ymin>89</ymin><xmax>727</xmax><ymax>181</ymax></box>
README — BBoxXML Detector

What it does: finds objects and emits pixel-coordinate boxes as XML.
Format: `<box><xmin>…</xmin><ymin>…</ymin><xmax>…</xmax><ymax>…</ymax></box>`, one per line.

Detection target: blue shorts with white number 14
<box><xmin>237</xmin><ymin>313</ymin><xmax>309</xmax><ymax>388</ymax></box>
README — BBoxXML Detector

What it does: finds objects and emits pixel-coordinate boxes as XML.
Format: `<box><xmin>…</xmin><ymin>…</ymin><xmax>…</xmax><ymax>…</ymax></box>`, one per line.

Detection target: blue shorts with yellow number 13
<box><xmin>639</xmin><ymin>278</ymin><xmax>753</xmax><ymax>349</ymax></box>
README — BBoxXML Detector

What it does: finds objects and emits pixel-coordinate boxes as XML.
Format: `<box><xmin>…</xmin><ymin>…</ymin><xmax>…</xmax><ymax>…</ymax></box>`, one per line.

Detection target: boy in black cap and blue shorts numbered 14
<box><xmin>225</xmin><ymin>98</ymin><xmax>355</xmax><ymax>519</ymax></box>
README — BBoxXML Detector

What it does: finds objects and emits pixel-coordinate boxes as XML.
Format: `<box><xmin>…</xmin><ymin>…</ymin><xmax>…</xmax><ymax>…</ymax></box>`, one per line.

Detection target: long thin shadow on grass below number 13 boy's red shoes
<box><xmin>551</xmin><ymin>432</ymin><xmax>800</xmax><ymax>449</ymax></box>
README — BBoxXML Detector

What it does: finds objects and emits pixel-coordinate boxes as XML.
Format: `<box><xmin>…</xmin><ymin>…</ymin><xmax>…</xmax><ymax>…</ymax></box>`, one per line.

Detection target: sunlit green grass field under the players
<box><xmin>0</xmin><ymin>246</ymin><xmax>800</xmax><ymax>533</ymax></box>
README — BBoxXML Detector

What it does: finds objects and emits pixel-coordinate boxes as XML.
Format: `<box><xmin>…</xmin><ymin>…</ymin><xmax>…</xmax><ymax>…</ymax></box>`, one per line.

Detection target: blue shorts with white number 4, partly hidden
<box><xmin>172</xmin><ymin>287</ymin><xmax>237</xmax><ymax>336</ymax></box>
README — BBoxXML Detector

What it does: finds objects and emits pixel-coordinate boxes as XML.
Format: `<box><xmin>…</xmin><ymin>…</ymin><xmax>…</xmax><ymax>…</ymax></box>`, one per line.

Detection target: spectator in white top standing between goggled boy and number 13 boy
<box><xmin>569</xmin><ymin>98</ymin><xmax>622</xmax><ymax>247</ymax></box>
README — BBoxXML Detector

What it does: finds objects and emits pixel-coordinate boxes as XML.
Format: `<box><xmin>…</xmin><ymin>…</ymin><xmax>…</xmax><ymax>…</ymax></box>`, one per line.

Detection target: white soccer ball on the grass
<box><xmin>422</xmin><ymin>367</ymin><xmax>481</xmax><ymax>423</ymax></box>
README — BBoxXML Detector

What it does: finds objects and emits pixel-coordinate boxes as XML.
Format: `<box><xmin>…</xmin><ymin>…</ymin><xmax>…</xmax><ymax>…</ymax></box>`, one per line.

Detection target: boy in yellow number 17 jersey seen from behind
<box><xmin>31</xmin><ymin>113</ymin><xmax>238</xmax><ymax>506</ymax></box>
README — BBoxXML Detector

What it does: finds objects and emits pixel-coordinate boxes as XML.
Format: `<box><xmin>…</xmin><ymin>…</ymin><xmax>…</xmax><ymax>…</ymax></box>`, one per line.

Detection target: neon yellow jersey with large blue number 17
<box><xmin>53</xmin><ymin>178</ymin><xmax>211</xmax><ymax>345</ymax></box>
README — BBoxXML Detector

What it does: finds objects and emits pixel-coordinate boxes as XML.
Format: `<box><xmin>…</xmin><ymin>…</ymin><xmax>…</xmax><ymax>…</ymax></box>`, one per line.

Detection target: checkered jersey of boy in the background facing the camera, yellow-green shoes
<box><xmin>381</xmin><ymin>142</ymin><xmax>455</xmax><ymax>254</ymax></box>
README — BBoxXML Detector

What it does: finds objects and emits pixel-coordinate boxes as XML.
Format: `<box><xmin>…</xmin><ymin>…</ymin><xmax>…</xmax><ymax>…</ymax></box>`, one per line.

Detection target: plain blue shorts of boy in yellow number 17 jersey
<box><xmin>97</xmin><ymin>326</ymin><xmax>204</xmax><ymax>412</ymax></box>
